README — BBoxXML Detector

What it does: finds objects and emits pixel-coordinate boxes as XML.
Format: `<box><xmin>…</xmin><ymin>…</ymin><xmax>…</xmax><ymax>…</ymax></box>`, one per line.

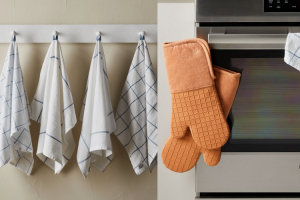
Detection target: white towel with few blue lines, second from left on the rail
<box><xmin>31</xmin><ymin>36</ymin><xmax>77</xmax><ymax>174</ymax></box>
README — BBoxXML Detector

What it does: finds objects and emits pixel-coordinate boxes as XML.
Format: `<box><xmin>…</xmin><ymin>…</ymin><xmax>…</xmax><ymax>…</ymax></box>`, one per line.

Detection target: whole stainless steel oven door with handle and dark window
<box><xmin>196</xmin><ymin>32</ymin><xmax>300</xmax><ymax>199</ymax></box>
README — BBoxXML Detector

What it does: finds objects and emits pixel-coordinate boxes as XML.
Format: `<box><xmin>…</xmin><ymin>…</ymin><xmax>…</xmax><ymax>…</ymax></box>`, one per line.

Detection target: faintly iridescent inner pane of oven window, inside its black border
<box><xmin>231</xmin><ymin>58</ymin><xmax>300</xmax><ymax>139</ymax></box>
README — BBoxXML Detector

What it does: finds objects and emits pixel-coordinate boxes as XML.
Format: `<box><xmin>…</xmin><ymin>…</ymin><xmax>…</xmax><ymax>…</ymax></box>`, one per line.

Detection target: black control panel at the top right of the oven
<box><xmin>264</xmin><ymin>0</ymin><xmax>300</xmax><ymax>12</ymax></box>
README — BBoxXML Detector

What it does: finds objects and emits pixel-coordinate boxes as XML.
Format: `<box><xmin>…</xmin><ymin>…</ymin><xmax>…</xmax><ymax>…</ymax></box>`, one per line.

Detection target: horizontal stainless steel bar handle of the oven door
<box><xmin>208</xmin><ymin>33</ymin><xmax>287</xmax><ymax>50</ymax></box>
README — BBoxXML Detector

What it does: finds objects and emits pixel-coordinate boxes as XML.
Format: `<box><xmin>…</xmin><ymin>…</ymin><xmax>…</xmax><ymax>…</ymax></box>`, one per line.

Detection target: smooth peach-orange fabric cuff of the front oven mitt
<box><xmin>162</xmin><ymin>39</ymin><xmax>215</xmax><ymax>94</ymax></box>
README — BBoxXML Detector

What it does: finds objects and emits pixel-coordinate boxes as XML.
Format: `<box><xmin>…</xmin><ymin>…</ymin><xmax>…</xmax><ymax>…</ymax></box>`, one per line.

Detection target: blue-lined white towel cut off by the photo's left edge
<box><xmin>0</xmin><ymin>36</ymin><xmax>33</xmax><ymax>175</ymax></box>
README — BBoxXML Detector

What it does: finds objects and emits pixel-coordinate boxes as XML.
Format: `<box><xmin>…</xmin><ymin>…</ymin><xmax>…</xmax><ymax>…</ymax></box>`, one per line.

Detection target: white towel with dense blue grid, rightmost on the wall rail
<box><xmin>115</xmin><ymin>36</ymin><xmax>157</xmax><ymax>175</ymax></box>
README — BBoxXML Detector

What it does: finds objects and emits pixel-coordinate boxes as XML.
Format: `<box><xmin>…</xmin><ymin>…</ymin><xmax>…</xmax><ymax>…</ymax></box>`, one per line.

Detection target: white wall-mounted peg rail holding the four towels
<box><xmin>0</xmin><ymin>24</ymin><xmax>157</xmax><ymax>43</ymax></box>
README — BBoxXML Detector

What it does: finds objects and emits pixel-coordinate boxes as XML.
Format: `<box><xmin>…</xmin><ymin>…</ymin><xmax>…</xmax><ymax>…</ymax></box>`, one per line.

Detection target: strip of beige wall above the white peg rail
<box><xmin>0</xmin><ymin>0</ymin><xmax>157</xmax><ymax>24</ymax></box>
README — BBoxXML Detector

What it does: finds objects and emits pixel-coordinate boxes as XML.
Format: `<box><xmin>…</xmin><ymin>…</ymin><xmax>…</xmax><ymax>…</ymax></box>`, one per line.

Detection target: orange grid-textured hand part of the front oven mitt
<box><xmin>171</xmin><ymin>87</ymin><xmax>229</xmax><ymax>149</ymax></box>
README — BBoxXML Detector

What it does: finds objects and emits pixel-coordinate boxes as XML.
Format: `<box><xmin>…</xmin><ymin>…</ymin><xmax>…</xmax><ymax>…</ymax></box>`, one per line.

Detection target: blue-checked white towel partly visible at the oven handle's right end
<box><xmin>284</xmin><ymin>33</ymin><xmax>300</xmax><ymax>71</ymax></box>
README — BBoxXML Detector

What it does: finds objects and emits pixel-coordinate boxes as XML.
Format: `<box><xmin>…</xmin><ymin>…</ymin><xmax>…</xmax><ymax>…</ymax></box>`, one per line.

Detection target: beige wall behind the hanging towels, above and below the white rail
<box><xmin>0</xmin><ymin>0</ymin><xmax>157</xmax><ymax>200</ymax></box>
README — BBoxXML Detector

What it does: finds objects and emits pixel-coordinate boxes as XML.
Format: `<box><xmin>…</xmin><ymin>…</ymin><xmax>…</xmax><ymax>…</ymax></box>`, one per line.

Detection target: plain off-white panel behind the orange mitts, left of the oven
<box><xmin>157</xmin><ymin>3</ymin><xmax>196</xmax><ymax>200</ymax></box>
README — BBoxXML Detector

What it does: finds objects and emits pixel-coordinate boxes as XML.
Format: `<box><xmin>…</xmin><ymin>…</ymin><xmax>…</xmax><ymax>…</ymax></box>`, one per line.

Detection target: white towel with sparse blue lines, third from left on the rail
<box><xmin>77</xmin><ymin>36</ymin><xmax>116</xmax><ymax>178</ymax></box>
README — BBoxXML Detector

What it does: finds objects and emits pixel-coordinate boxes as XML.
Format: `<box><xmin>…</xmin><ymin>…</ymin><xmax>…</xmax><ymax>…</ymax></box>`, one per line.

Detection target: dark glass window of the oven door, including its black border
<box><xmin>212</xmin><ymin>50</ymin><xmax>300</xmax><ymax>152</ymax></box>
